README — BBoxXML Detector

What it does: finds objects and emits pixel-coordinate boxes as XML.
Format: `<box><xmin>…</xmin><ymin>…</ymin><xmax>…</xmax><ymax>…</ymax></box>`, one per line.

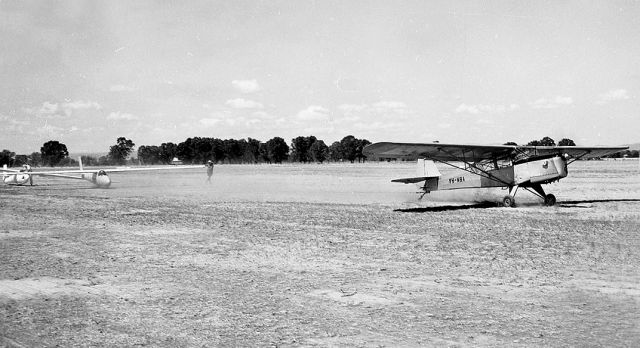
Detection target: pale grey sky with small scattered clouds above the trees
<box><xmin>0</xmin><ymin>0</ymin><xmax>640</xmax><ymax>154</ymax></box>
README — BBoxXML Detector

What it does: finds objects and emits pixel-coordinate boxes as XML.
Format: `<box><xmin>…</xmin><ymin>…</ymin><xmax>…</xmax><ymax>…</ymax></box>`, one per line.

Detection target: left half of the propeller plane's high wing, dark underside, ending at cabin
<box><xmin>363</xmin><ymin>142</ymin><xmax>517</xmax><ymax>162</ymax></box>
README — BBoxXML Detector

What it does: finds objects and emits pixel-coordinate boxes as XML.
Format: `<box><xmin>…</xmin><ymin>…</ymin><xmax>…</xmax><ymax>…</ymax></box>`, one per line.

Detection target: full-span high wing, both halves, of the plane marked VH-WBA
<box><xmin>363</xmin><ymin>142</ymin><xmax>628</xmax><ymax>163</ymax></box>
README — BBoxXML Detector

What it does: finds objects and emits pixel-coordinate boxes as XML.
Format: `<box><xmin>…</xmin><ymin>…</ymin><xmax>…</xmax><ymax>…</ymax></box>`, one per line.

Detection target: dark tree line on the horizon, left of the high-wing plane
<box><xmin>0</xmin><ymin>135</ymin><xmax>371</xmax><ymax>167</ymax></box>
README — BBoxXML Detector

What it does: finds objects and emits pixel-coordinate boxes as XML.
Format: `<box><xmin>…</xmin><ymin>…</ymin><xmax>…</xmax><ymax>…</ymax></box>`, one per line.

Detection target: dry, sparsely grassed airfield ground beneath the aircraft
<box><xmin>0</xmin><ymin>161</ymin><xmax>640</xmax><ymax>347</ymax></box>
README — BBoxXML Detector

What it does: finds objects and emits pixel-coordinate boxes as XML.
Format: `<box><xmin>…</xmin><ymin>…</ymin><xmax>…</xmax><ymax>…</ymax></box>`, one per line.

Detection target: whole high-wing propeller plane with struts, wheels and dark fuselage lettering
<box><xmin>363</xmin><ymin>142</ymin><xmax>628</xmax><ymax>207</ymax></box>
